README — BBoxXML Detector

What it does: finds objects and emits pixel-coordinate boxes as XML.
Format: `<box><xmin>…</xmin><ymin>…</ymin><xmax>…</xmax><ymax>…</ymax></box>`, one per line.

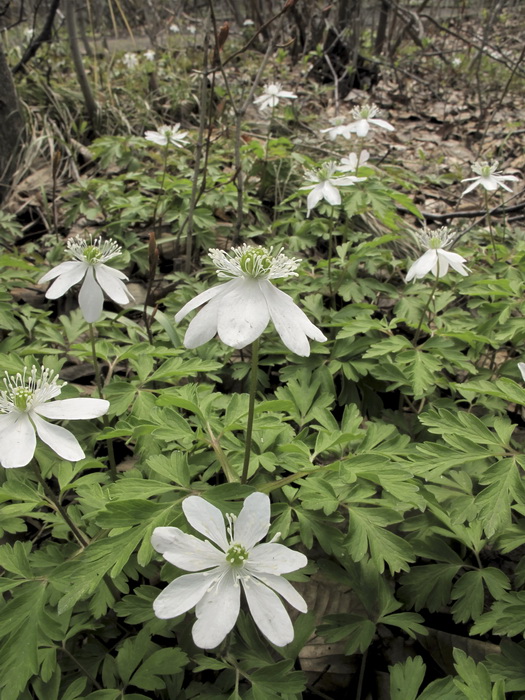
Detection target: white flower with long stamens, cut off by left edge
<box><xmin>0</xmin><ymin>367</ymin><xmax>109</xmax><ymax>469</ymax></box>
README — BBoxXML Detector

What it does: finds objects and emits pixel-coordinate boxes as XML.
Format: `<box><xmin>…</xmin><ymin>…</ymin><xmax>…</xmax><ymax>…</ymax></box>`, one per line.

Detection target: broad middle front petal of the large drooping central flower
<box><xmin>217</xmin><ymin>278</ymin><xmax>270</xmax><ymax>350</ymax></box>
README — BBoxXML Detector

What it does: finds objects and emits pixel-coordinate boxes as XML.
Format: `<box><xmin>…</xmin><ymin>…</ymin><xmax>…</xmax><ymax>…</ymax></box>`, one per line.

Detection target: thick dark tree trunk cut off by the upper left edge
<box><xmin>0</xmin><ymin>44</ymin><xmax>24</xmax><ymax>202</ymax></box>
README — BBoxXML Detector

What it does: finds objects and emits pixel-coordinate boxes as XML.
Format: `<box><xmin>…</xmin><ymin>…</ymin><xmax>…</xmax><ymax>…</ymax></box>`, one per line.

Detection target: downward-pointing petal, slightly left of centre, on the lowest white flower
<box><xmin>191</xmin><ymin>569</ymin><xmax>241</xmax><ymax>649</ymax></box>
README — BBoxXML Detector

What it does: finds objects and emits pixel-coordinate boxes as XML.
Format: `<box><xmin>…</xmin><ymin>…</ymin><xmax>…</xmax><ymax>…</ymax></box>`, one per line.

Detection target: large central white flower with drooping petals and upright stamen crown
<box><xmin>175</xmin><ymin>243</ymin><xmax>326</xmax><ymax>357</ymax></box>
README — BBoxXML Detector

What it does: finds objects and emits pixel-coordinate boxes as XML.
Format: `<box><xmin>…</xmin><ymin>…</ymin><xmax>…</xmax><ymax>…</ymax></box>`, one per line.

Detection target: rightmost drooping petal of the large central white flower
<box><xmin>261</xmin><ymin>282</ymin><xmax>326</xmax><ymax>357</ymax></box>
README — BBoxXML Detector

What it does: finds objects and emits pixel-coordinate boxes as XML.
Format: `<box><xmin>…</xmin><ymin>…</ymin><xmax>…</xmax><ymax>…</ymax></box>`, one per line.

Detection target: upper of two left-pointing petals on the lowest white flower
<box><xmin>151</xmin><ymin>527</ymin><xmax>225</xmax><ymax>571</ymax></box>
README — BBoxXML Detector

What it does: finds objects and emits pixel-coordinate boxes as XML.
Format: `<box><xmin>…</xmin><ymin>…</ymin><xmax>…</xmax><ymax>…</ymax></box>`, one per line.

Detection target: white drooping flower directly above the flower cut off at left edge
<box><xmin>38</xmin><ymin>236</ymin><xmax>134</xmax><ymax>323</ymax></box>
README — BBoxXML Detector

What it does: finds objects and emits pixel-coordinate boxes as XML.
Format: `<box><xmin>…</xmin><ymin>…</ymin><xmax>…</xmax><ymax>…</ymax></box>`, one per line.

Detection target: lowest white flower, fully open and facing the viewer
<box><xmin>151</xmin><ymin>493</ymin><xmax>308</xmax><ymax>649</ymax></box>
